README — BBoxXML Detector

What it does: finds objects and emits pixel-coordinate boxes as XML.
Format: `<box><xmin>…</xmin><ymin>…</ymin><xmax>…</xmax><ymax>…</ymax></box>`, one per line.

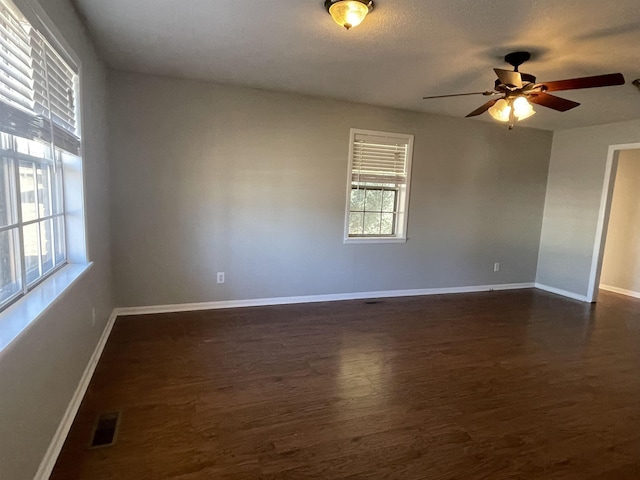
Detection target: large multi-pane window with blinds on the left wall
<box><xmin>0</xmin><ymin>0</ymin><xmax>80</xmax><ymax>309</ymax></box>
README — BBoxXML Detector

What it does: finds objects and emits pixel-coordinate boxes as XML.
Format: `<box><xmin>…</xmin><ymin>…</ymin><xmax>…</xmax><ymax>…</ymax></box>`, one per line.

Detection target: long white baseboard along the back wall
<box><xmin>114</xmin><ymin>283</ymin><xmax>535</xmax><ymax>315</ymax></box>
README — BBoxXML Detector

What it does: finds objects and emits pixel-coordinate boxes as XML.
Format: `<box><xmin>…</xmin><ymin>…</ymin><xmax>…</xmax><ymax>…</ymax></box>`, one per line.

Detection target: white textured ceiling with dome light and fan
<box><xmin>74</xmin><ymin>0</ymin><xmax>640</xmax><ymax>130</ymax></box>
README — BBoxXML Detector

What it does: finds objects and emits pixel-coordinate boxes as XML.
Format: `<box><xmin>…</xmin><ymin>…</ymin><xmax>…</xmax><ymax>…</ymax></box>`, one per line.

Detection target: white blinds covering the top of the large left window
<box><xmin>0</xmin><ymin>0</ymin><xmax>80</xmax><ymax>154</ymax></box>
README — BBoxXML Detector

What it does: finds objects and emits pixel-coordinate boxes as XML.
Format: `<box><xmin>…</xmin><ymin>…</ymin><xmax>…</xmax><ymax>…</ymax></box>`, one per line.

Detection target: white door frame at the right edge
<box><xmin>587</xmin><ymin>143</ymin><xmax>640</xmax><ymax>302</ymax></box>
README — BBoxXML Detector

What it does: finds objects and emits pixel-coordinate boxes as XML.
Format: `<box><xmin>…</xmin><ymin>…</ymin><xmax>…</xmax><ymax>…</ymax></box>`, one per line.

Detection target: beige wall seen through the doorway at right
<box><xmin>600</xmin><ymin>150</ymin><xmax>640</xmax><ymax>295</ymax></box>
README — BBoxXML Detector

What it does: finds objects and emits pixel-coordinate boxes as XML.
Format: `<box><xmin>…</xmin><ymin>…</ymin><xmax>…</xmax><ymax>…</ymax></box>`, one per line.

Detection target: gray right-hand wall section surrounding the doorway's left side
<box><xmin>537</xmin><ymin>120</ymin><xmax>640</xmax><ymax>296</ymax></box>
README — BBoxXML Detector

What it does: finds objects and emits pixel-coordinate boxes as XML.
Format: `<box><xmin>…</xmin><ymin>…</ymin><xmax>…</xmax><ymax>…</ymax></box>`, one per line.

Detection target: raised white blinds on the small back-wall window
<box><xmin>351</xmin><ymin>133</ymin><xmax>409</xmax><ymax>185</ymax></box>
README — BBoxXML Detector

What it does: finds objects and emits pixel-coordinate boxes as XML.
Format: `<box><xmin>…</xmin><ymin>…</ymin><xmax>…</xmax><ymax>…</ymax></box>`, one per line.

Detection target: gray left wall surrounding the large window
<box><xmin>0</xmin><ymin>0</ymin><xmax>114</xmax><ymax>480</ymax></box>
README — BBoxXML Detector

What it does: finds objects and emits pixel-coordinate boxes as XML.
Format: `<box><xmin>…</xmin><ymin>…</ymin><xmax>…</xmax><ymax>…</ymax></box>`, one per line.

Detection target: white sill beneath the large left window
<box><xmin>0</xmin><ymin>263</ymin><xmax>92</xmax><ymax>355</ymax></box>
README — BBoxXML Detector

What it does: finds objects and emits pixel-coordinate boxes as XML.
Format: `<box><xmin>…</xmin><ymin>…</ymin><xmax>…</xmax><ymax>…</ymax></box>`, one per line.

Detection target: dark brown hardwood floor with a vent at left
<box><xmin>52</xmin><ymin>290</ymin><xmax>640</xmax><ymax>480</ymax></box>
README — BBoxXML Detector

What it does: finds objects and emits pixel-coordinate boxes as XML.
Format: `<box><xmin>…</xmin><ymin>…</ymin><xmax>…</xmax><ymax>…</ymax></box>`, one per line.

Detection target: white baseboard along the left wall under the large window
<box><xmin>34</xmin><ymin>310</ymin><xmax>117</xmax><ymax>480</ymax></box>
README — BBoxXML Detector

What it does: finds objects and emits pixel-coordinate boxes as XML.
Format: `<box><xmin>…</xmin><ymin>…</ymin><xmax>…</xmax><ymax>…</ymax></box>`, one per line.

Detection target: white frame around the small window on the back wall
<box><xmin>344</xmin><ymin>128</ymin><xmax>414</xmax><ymax>244</ymax></box>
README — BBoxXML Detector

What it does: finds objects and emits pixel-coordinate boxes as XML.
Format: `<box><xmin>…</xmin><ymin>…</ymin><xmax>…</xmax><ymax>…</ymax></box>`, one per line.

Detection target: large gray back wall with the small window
<box><xmin>109</xmin><ymin>71</ymin><xmax>552</xmax><ymax>306</ymax></box>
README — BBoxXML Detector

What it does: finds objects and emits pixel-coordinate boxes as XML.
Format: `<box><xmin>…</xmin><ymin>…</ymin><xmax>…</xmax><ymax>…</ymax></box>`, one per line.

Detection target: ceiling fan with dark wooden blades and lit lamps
<box><xmin>423</xmin><ymin>52</ymin><xmax>624</xmax><ymax>130</ymax></box>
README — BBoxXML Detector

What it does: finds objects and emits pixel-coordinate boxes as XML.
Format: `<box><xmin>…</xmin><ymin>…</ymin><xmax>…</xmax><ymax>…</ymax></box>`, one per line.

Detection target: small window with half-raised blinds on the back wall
<box><xmin>345</xmin><ymin>129</ymin><xmax>413</xmax><ymax>243</ymax></box>
